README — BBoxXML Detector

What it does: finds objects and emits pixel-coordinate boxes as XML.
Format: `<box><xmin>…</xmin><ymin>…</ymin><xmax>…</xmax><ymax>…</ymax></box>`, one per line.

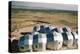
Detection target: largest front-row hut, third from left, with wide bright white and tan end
<box><xmin>47</xmin><ymin>32</ymin><xmax>63</xmax><ymax>50</ymax></box>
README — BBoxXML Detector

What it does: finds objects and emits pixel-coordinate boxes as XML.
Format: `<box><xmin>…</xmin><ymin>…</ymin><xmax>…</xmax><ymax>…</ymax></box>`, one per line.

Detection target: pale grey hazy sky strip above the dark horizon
<box><xmin>12</xmin><ymin>1</ymin><xmax>78</xmax><ymax>11</ymax></box>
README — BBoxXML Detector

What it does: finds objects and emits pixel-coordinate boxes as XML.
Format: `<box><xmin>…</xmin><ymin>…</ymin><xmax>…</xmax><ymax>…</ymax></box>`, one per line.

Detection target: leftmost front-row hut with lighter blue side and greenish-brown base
<box><xmin>18</xmin><ymin>32</ymin><xmax>32</xmax><ymax>52</ymax></box>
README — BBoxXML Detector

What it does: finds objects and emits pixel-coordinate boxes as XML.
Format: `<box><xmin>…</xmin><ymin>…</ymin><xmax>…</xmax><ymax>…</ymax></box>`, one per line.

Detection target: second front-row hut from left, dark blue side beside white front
<box><xmin>33</xmin><ymin>33</ymin><xmax>46</xmax><ymax>51</ymax></box>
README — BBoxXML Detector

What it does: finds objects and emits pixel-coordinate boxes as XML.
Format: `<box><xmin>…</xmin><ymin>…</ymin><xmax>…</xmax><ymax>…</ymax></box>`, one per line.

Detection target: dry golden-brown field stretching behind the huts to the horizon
<box><xmin>11</xmin><ymin>9</ymin><xmax>78</xmax><ymax>37</ymax></box>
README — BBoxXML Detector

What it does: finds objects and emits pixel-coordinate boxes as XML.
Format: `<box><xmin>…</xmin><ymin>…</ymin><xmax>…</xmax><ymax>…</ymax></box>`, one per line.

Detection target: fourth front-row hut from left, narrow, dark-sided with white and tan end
<box><xmin>62</xmin><ymin>32</ymin><xmax>73</xmax><ymax>47</ymax></box>
